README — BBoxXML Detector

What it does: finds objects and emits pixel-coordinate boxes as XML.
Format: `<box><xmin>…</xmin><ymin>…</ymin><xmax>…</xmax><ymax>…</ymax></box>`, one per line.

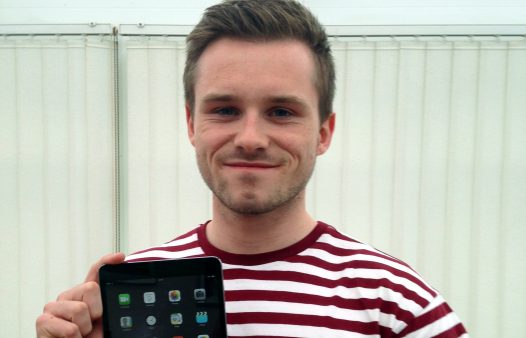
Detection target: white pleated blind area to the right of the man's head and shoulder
<box><xmin>311</xmin><ymin>37</ymin><xmax>526</xmax><ymax>337</ymax></box>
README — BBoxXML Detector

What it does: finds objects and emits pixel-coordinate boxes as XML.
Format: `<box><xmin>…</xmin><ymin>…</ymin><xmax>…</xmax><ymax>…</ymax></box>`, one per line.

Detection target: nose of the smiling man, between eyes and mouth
<box><xmin>234</xmin><ymin>112</ymin><xmax>269</xmax><ymax>153</ymax></box>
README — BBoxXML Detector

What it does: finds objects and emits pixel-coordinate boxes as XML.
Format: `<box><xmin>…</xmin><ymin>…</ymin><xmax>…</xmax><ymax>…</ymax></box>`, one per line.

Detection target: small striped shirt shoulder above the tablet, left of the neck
<box><xmin>126</xmin><ymin>226</ymin><xmax>203</xmax><ymax>262</ymax></box>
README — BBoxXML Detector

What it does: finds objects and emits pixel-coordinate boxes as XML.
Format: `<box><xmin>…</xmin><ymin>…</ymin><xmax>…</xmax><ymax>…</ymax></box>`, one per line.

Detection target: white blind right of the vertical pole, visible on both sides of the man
<box><xmin>123</xmin><ymin>33</ymin><xmax>526</xmax><ymax>338</ymax></box>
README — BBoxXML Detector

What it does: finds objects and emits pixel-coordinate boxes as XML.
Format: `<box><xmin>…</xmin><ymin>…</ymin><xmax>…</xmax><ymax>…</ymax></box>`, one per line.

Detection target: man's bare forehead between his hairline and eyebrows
<box><xmin>194</xmin><ymin>38</ymin><xmax>317</xmax><ymax>105</ymax></box>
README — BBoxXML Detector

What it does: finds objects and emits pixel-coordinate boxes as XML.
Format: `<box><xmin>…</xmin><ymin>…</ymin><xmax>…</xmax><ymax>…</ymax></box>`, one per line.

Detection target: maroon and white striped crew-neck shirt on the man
<box><xmin>127</xmin><ymin>222</ymin><xmax>468</xmax><ymax>338</ymax></box>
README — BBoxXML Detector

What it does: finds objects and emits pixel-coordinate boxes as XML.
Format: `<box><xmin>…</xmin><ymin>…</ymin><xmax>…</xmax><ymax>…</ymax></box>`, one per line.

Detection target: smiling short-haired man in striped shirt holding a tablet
<box><xmin>37</xmin><ymin>0</ymin><xmax>467</xmax><ymax>337</ymax></box>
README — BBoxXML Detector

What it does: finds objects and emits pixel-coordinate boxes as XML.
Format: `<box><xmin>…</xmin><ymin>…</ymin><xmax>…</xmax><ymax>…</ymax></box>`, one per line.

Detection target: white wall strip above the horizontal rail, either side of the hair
<box><xmin>0</xmin><ymin>0</ymin><xmax>526</xmax><ymax>25</ymax></box>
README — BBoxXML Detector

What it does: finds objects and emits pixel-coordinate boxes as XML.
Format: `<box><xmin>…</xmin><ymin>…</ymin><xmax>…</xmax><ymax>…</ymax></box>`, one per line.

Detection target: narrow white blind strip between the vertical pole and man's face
<box><xmin>121</xmin><ymin>37</ymin><xmax>210</xmax><ymax>252</ymax></box>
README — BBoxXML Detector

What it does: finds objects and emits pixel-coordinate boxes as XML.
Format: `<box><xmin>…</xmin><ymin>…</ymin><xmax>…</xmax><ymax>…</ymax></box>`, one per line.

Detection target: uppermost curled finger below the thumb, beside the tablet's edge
<box><xmin>57</xmin><ymin>282</ymin><xmax>102</xmax><ymax>322</ymax></box>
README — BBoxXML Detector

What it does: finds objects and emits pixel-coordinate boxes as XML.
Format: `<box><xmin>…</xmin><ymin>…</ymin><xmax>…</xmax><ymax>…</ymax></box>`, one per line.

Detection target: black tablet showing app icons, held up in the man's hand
<box><xmin>99</xmin><ymin>257</ymin><xmax>227</xmax><ymax>338</ymax></box>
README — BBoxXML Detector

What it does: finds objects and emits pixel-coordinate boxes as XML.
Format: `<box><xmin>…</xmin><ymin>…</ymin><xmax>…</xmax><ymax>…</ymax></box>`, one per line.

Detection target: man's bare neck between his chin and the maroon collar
<box><xmin>206</xmin><ymin>193</ymin><xmax>316</xmax><ymax>254</ymax></box>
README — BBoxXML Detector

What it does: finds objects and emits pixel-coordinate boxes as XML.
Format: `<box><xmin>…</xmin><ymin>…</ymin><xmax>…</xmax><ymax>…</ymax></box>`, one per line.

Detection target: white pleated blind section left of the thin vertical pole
<box><xmin>0</xmin><ymin>36</ymin><xmax>115</xmax><ymax>337</ymax></box>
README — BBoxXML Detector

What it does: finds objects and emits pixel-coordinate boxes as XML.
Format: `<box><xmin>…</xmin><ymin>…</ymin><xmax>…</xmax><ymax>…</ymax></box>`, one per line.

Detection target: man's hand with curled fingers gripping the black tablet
<box><xmin>36</xmin><ymin>253</ymin><xmax>124</xmax><ymax>338</ymax></box>
